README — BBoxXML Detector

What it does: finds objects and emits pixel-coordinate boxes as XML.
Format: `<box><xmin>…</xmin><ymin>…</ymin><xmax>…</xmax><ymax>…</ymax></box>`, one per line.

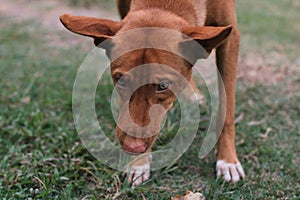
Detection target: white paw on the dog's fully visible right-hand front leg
<box><xmin>216</xmin><ymin>160</ymin><xmax>245</xmax><ymax>183</ymax></box>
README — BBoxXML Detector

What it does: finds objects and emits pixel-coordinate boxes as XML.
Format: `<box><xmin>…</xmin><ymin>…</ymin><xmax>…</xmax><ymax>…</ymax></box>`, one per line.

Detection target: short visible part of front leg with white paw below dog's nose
<box><xmin>123</xmin><ymin>153</ymin><xmax>152</xmax><ymax>188</ymax></box>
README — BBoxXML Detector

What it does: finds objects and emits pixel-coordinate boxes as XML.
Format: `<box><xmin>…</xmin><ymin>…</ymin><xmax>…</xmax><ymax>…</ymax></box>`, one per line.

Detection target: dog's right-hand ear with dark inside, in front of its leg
<box><xmin>179</xmin><ymin>25</ymin><xmax>232</xmax><ymax>61</ymax></box>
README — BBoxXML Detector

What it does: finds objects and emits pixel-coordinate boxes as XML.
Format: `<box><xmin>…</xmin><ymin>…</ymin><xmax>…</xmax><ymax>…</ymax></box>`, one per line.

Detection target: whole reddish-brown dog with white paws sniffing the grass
<box><xmin>60</xmin><ymin>0</ymin><xmax>244</xmax><ymax>185</ymax></box>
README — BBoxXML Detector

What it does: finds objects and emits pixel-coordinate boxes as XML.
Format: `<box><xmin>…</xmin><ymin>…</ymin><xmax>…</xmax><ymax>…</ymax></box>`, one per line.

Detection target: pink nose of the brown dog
<box><xmin>122</xmin><ymin>137</ymin><xmax>147</xmax><ymax>153</ymax></box>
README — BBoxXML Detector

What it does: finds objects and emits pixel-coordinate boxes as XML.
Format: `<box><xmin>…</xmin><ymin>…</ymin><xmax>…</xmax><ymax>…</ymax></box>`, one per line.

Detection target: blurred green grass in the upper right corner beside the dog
<box><xmin>237</xmin><ymin>0</ymin><xmax>300</xmax><ymax>57</ymax></box>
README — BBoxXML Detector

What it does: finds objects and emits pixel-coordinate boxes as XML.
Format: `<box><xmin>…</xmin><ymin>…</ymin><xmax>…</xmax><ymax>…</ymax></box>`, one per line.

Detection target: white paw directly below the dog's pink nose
<box><xmin>124</xmin><ymin>163</ymin><xmax>150</xmax><ymax>188</ymax></box>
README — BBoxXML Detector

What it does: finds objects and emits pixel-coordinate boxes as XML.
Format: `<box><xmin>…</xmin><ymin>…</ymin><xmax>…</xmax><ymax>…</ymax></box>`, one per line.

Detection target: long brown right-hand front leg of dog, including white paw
<box><xmin>216</xmin><ymin>27</ymin><xmax>245</xmax><ymax>182</ymax></box>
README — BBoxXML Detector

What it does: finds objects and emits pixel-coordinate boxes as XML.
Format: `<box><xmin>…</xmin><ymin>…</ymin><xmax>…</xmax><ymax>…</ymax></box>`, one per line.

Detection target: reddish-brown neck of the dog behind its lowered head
<box><xmin>122</xmin><ymin>0</ymin><xmax>206</xmax><ymax>31</ymax></box>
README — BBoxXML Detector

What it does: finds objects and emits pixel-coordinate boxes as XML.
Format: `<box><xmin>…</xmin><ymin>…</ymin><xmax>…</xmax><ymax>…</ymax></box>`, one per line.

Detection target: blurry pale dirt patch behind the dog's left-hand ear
<box><xmin>0</xmin><ymin>0</ymin><xmax>119</xmax><ymax>48</ymax></box>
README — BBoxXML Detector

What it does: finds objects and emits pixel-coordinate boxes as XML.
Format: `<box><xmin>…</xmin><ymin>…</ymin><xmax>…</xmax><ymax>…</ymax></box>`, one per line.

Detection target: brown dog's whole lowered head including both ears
<box><xmin>60</xmin><ymin>13</ymin><xmax>232</xmax><ymax>153</ymax></box>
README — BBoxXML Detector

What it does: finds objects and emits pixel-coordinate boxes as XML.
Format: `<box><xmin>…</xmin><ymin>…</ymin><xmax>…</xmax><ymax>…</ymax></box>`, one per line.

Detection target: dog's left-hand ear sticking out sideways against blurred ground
<box><xmin>59</xmin><ymin>14</ymin><xmax>121</xmax><ymax>46</ymax></box>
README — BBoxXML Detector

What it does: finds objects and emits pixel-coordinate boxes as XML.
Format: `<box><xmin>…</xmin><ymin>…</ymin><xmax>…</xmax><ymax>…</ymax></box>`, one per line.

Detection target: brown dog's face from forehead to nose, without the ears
<box><xmin>111</xmin><ymin>48</ymin><xmax>192</xmax><ymax>153</ymax></box>
